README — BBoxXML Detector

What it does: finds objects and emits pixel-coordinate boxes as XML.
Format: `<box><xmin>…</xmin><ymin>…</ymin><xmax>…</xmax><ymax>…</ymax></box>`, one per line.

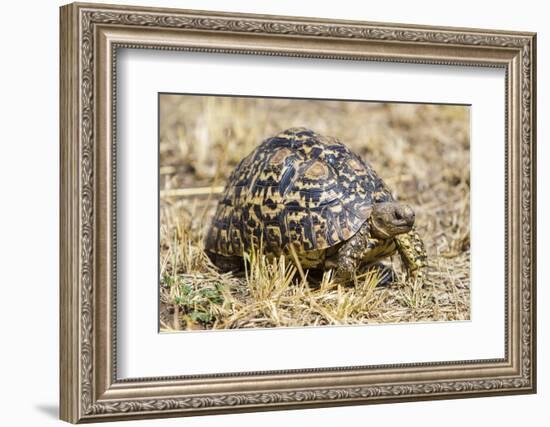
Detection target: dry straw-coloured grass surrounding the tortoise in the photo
<box><xmin>160</xmin><ymin>95</ymin><xmax>470</xmax><ymax>331</ymax></box>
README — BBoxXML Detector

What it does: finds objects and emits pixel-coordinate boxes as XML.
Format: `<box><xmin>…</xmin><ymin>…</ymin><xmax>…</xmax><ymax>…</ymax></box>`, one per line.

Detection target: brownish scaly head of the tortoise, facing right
<box><xmin>370</xmin><ymin>202</ymin><xmax>414</xmax><ymax>239</ymax></box>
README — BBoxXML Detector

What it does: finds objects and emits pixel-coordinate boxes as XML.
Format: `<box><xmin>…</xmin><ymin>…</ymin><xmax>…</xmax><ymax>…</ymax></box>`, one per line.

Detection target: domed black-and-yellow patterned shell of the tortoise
<box><xmin>205</xmin><ymin>128</ymin><xmax>393</xmax><ymax>256</ymax></box>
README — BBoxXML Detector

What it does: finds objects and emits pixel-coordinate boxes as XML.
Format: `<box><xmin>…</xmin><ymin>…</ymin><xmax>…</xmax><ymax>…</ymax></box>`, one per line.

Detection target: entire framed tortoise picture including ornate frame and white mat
<box><xmin>60</xmin><ymin>4</ymin><xmax>536</xmax><ymax>423</ymax></box>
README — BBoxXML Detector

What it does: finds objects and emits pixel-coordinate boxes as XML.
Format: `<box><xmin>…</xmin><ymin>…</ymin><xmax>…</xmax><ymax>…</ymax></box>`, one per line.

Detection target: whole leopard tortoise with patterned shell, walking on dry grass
<box><xmin>205</xmin><ymin>128</ymin><xmax>426</xmax><ymax>280</ymax></box>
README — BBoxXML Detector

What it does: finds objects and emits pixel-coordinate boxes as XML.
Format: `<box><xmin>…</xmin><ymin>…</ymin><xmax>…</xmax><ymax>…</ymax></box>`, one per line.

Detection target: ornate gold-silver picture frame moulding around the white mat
<box><xmin>60</xmin><ymin>3</ymin><xmax>536</xmax><ymax>423</ymax></box>
